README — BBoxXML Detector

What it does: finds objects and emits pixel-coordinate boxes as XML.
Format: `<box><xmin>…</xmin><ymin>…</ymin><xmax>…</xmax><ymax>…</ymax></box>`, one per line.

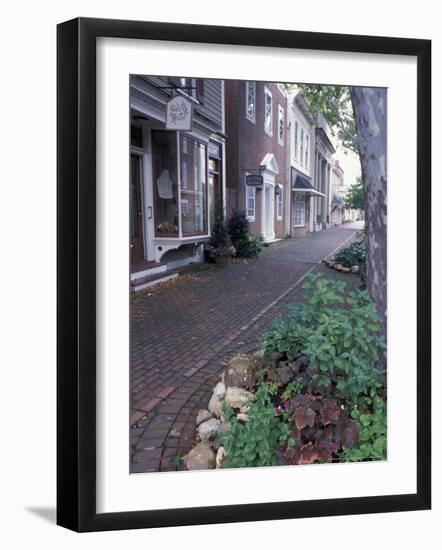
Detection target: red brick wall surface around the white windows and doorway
<box><xmin>225</xmin><ymin>80</ymin><xmax>290</xmax><ymax>238</ymax></box>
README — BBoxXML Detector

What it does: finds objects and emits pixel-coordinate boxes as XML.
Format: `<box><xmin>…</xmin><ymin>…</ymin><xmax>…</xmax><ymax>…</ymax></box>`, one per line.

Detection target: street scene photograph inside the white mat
<box><xmin>129</xmin><ymin>74</ymin><xmax>388</xmax><ymax>475</ymax></box>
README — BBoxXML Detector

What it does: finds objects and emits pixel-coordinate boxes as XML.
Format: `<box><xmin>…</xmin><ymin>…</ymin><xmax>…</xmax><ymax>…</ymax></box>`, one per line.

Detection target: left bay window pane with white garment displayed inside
<box><xmin>152</xmin><ymin>132</ymin><xmax>178</xmax><ymax>237</ymax></box>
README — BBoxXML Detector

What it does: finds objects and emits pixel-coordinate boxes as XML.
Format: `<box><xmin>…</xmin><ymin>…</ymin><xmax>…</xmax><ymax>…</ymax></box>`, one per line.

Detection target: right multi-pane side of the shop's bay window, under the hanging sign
<box><xmin>180</xmin><ymin>135</ymin><xmax>207</xmax><ymax>237</ymax></box>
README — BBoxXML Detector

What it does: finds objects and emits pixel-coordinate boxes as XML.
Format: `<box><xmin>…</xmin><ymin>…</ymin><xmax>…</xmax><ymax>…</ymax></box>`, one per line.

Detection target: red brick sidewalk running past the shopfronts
<box><xmin>130</xmin><ymin>225</ymin><xmax>359</xmax><ymax>473</ymax></box>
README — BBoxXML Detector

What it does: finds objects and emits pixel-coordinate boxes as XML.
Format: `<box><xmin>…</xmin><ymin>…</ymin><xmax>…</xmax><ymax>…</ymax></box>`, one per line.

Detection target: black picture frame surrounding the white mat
<box><xmin>57</xmin><ymin>18</ymin><xmax>431</xmax><ymax>531</ymax></box>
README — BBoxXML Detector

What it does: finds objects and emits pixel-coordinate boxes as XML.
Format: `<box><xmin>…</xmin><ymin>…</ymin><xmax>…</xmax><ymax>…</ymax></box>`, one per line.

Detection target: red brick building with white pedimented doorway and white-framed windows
<box><xmin>225</xmin><ymin>80</ymin><xmax>290</xmax><ymax>242</ymax></box>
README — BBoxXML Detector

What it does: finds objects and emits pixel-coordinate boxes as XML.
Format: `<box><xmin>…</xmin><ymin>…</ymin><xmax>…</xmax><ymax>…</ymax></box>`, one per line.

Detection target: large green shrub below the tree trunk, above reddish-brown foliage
<box><xmin>262</xmin><ymin>274</ymin><xmax>385</xmax><ymax>400</ymax></box>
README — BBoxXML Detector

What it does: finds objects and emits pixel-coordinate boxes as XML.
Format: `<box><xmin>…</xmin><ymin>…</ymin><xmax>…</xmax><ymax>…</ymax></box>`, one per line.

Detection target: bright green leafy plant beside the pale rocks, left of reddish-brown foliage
<box><xmin>218</xmin><ymin>383</ymin><xmax>290</xmax><ymax>468</ymax></box>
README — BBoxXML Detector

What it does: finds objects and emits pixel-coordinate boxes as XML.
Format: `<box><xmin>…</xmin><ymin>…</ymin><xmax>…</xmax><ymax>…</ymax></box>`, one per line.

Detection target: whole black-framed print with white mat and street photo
<box><xmin>57</xmin><ymin>18</ymin><xmax>431</xmax><ymax>531</ymax></box>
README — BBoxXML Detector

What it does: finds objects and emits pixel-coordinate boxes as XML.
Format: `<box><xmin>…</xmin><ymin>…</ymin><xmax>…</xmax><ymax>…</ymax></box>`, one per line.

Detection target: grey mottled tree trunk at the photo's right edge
<box><xmin>350</xmin><ymin>87</ymin><xmax>387</xmax><ymax>354</ymax></box>
